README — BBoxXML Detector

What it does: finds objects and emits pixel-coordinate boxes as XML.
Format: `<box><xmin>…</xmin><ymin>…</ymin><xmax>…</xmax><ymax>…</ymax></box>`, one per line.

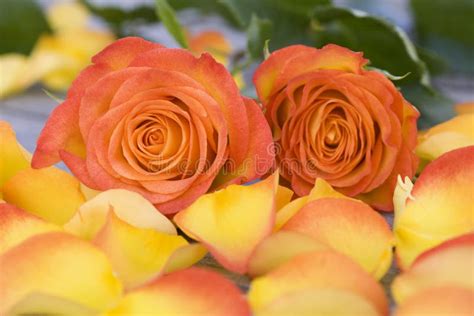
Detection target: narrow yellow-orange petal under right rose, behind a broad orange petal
<box><xmin>275</xmin><ymin>178</ymin><xmax>351</xmax><ymax>230</ymax></box>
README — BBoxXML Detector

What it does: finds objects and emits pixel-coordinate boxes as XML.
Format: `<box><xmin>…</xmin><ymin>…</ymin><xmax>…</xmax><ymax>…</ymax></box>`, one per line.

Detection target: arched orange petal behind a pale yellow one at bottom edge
<box><xmin>248</xmin><ymin>251</ymin><xmax>388</xmax><ymax>315</ymax></box>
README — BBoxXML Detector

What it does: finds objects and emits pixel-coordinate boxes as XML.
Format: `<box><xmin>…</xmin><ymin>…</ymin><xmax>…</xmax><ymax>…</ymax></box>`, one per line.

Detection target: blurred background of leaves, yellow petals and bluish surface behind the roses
<box><xmin>0</xmin><ymin>0</ymin><xmax>474</xmax><ymax>151</ymax></box>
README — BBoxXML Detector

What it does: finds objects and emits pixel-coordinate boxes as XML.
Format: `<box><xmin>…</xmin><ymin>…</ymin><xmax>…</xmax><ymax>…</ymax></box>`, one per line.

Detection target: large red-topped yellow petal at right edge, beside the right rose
<box><xmin>394</xmin><ymin>146</ymin><xmax>474</xmax><ymax>269</ymax></box>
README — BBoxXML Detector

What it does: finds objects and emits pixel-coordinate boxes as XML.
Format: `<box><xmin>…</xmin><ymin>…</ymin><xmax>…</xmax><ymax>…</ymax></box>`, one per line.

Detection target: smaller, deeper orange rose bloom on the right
<box><xmin>254</xmin><ymin>45</ymin><xmax>419</xmax><ymax>210</ymax></box>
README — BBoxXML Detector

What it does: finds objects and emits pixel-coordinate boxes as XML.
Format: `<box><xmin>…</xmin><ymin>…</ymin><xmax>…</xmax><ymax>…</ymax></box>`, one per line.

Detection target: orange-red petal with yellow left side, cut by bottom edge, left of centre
<box><xmin>107</xmin><ymin>268</ymin><xmax>250</xmax><ymax>316</ymax></box>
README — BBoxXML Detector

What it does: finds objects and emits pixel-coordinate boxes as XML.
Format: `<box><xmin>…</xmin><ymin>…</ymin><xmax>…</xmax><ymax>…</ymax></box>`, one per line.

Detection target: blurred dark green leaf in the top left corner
<box><xmin>0</xmin><ymin>0</ymin><xmax>50</xmax><ymax>54</ymax></box>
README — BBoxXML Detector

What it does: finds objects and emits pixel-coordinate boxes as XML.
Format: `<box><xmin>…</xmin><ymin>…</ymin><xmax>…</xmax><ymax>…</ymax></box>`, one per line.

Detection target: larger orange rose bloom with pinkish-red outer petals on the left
<box><xmin>32</xmin><ymin>38</ymin><xmax>274</xmax><ymax>213</ymax></box>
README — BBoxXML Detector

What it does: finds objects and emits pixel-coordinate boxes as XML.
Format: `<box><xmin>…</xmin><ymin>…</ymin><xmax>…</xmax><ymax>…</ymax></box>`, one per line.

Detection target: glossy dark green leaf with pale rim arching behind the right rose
<box><xmin>313</xmin><ymin>6</ymin><xmax>430</xmax><ymax>86</ymax></box>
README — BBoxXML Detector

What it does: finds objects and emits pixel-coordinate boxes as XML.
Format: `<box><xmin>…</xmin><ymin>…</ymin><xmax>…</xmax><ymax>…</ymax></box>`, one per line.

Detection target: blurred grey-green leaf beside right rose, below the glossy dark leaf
<box><xmin>400</xmin><ymin>84</ymin><xmax>455</xmax><ymax>129</ymax></box>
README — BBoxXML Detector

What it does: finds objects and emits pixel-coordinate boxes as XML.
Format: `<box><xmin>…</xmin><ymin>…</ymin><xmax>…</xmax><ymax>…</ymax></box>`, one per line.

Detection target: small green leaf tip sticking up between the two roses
<box><xmin>247</xmin><ymin>14</ymin><xmax>273</xmax><ymax>59</ymax></box>
